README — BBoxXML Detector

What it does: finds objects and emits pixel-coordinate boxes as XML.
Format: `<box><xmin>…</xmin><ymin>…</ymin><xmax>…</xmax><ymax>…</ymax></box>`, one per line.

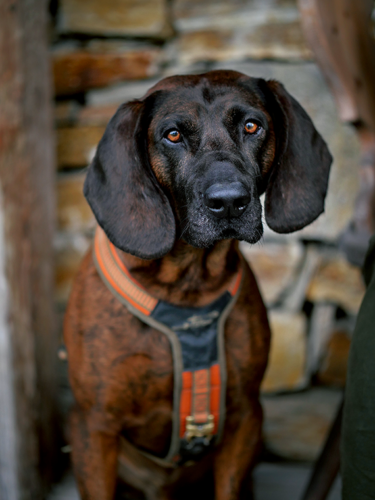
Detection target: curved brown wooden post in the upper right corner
<box><xmin>299</xmin><ymin>0</ymin><xmax>375</xmax><ymax>266</ymax></box>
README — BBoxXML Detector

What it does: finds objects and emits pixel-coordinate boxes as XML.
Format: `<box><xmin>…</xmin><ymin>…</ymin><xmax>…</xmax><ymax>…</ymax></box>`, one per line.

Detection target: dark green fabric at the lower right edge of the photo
<box><xmin>341</xmin><ymin>236</ymin><xmax>375</xmax><ymax>500</ymax></box>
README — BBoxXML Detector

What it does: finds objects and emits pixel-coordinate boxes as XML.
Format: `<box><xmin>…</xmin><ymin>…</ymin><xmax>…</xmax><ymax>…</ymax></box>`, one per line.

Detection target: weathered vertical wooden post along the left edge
<box><xmin>0</xmin><ymin>0</ymin><xmax>58</xmax><ymax>500</ymax></box>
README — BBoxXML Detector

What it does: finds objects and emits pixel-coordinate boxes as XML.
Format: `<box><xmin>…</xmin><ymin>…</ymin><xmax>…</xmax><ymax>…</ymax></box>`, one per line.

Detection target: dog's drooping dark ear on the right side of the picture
<box><xmin>263</xmin><ymin>80</ymin><xmax>332</xmax><ymax>233</ymax></box>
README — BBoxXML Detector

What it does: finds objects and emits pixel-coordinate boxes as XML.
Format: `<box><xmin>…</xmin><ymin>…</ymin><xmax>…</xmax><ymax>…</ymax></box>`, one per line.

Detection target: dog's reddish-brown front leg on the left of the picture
<box><xmin>71</xmin><ymin>407</ymin><xmax>118</xmax><ymax>500</ymax></box>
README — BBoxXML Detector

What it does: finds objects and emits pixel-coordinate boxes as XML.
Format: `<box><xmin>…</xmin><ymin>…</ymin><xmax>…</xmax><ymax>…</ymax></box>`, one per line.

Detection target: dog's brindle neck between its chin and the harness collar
<box><xmin>119</xmin><ymin>240</ymin><xmax>240</xmax><ymax>307</ymax></box>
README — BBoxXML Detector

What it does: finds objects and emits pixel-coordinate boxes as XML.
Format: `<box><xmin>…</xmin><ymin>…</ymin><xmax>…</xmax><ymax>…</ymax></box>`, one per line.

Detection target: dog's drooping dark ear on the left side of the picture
<box><xmin>84</xmin><ymin>101</ymin><xmax>176</xmax><ymax>259</ymax></box>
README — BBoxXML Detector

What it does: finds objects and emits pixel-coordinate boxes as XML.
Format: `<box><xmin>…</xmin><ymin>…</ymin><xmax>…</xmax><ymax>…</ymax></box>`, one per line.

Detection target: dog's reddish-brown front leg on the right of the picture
<box><xmin>214</xmin><ymin>401</ymin><xmax>262</xmax><ymax>500</ymax></box>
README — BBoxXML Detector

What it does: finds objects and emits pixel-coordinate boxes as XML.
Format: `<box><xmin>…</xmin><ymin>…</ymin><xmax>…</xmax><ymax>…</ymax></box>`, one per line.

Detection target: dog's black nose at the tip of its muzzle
<box><xmin>204</xmin><ymin>182</ymin><xmax>250</xmax><ymax>219</ymax></box>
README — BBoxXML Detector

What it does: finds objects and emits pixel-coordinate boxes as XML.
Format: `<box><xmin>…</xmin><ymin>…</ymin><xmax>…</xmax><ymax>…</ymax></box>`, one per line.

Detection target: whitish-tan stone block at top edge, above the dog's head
<box><xmin>172</xmin><ymin>0</ymin><xmax>312</xmax><ymax>64</ymax></box>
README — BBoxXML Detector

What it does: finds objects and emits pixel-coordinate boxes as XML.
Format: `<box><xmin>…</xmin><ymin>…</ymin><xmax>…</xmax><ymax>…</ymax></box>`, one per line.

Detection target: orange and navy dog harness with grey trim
<box><xmin>94</xmin><ymin>227</ymin><xmax>242</xmax><ymax>465</ymax></box>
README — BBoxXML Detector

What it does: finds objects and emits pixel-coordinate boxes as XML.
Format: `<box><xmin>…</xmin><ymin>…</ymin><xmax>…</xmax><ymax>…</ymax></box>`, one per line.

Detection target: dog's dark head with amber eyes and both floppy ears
<box><xmin>84</xmin><ymin>71</ymin><xmax>332</xmax><ymax>259</ymax></box>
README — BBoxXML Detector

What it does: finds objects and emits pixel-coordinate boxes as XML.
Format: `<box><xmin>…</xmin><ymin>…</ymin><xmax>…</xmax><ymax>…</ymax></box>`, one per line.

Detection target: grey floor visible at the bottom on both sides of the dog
<box><xmin>48</xmin><ymin>463</ymin><xmax>341</xmax><ymax>500</ymax></box>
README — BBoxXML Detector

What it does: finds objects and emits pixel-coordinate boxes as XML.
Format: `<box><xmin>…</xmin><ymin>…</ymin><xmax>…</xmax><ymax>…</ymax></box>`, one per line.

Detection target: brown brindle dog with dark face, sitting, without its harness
<box><xmin>65</xmin><ymin>71</ymin><xmax>331</xmax><ymax>500</ymax></box>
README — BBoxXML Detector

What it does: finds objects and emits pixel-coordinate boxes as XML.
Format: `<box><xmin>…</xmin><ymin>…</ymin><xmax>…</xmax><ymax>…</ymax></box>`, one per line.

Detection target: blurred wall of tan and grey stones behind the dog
<box><xmin>51</xmin><ymin>0</ymin><xmax>364</xmax><ymax>460</ymax></box>
